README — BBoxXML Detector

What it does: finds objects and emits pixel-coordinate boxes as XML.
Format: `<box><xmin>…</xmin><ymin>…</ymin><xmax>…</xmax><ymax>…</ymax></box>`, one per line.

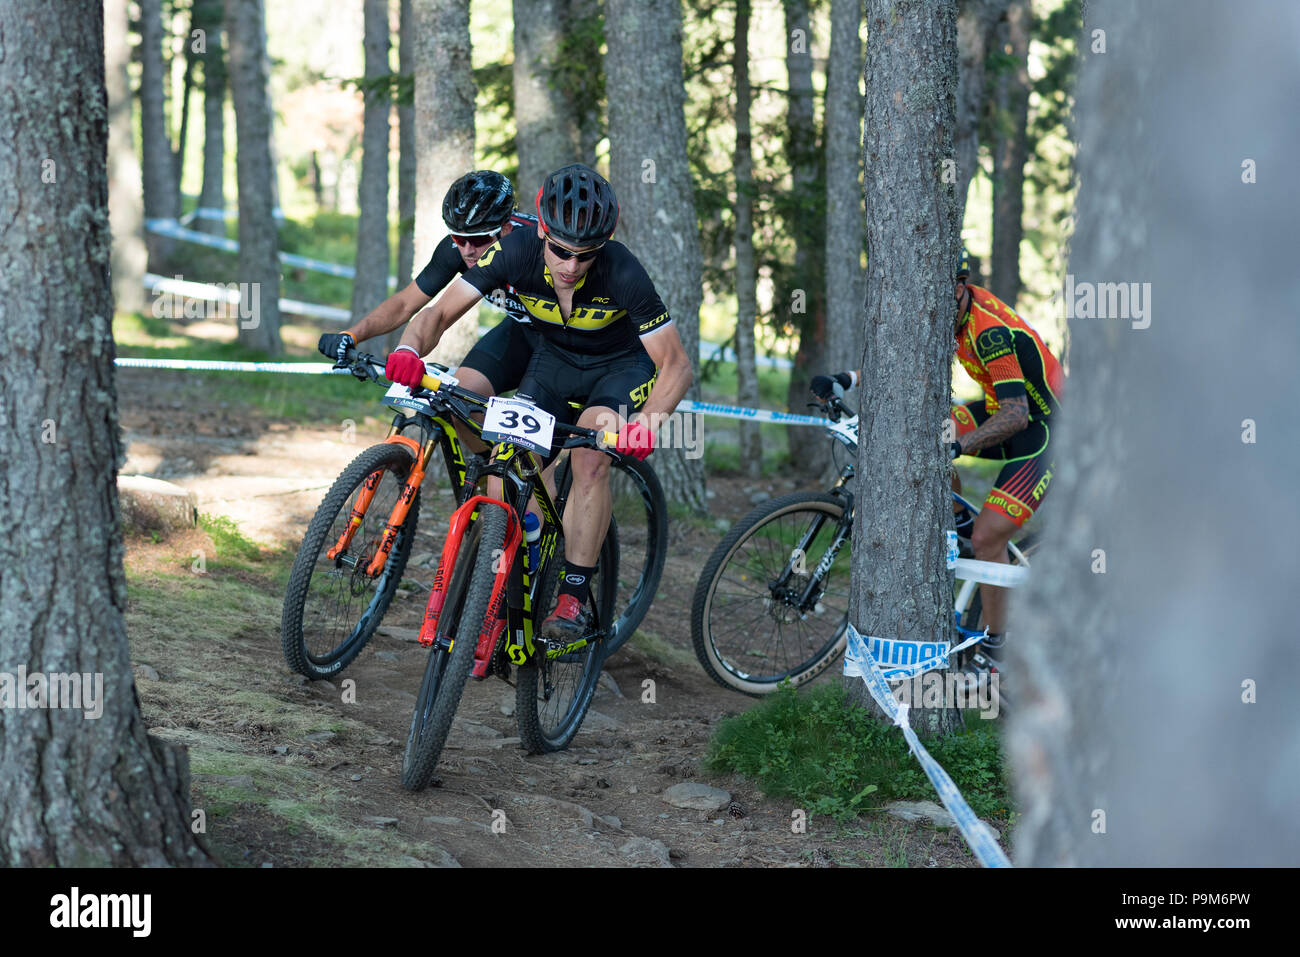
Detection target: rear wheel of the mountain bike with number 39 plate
<box><xmin>515</xmin><ymin>521</ymin><xmax>619</xmax><ymax>754</ymax></box>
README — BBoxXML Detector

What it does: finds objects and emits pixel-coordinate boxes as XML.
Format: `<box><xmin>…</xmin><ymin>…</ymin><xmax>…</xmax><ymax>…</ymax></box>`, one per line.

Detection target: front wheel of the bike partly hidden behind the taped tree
<box><xmin>690</xmin><ymin>492</ymin><xmax>849</xmax><ymax>697</ymax></box>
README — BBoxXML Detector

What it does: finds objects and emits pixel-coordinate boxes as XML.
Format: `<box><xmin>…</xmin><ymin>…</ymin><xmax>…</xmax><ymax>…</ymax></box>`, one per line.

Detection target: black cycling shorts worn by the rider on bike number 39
<box><xmin>519</xmin><ymin>337</ymin><xmax>657</xmax><ymax>434</ymax></box>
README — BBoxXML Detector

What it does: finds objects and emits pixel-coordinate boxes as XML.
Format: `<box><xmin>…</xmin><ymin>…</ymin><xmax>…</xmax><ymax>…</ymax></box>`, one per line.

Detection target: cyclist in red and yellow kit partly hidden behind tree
<box><xmin>811</xmin><ymin>250</ymin><xmax>1065</xmax><ymax>658</ymax></box>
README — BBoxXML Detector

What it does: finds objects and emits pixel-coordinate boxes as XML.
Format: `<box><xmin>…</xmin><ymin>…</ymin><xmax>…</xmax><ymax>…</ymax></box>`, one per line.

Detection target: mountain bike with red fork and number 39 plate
<box><xmin>387</xmin><ymin>361</ymin><xmax>647</xmax><ymax>791</ymax></box>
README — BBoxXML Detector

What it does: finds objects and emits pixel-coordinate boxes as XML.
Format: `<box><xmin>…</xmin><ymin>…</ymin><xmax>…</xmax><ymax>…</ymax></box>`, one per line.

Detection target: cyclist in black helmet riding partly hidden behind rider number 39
<box><xmin>316</xmin><ymin>169</ymin><xmax>537</xmax><ymax>450</ymax></box>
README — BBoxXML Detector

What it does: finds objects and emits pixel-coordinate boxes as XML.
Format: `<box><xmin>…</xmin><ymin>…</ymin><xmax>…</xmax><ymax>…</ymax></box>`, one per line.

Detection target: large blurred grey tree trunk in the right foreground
<box><xmin>1006</xmin><ymin>0</ymin><xmax>1300</xmax><ymax>867</ymax></box>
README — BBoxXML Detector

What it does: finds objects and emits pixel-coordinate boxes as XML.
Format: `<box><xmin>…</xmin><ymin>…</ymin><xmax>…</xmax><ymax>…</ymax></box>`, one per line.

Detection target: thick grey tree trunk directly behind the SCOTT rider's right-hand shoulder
<box><xmin>605</xmin><ymin>0</ymin><xmax>705</xmax><ymax>512</ymax></box>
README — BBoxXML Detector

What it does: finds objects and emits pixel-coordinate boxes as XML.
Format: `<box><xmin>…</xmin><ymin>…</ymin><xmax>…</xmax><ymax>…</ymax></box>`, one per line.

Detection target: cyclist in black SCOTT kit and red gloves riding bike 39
<box><xmin>385</xmin><ymin>164</ymin><xmax>692</xmax><ymax>641</ymax></box>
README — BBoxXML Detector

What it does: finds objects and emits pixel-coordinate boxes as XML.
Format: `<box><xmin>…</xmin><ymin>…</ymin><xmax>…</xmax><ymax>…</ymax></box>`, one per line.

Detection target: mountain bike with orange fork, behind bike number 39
<box><xmin>281</xmin><ymin>348</ymin><xmax>668</xmax><ymax>680</ymax></box>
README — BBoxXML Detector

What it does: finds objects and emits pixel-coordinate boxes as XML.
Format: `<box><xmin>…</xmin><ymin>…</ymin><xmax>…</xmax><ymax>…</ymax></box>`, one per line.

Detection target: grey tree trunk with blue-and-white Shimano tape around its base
<box><xmin>849</xmin><ymin>0</ymin><xmax>961</xmax><ymax>732</ymax></box>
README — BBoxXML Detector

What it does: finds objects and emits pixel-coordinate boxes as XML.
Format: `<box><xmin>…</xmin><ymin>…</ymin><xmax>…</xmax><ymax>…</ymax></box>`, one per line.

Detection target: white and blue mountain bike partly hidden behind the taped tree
<box><xmin>690</xmin><ymin>395</ymin><xmax>1036</xmax><ymax>697</ymax></box>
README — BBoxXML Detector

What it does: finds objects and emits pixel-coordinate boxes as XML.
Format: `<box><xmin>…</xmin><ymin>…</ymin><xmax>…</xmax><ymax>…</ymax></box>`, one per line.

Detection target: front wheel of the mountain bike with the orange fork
<box><xmin>281</xmin><ymin>442</ymin><xmax>420</xmax><ymax>680</ymax></box>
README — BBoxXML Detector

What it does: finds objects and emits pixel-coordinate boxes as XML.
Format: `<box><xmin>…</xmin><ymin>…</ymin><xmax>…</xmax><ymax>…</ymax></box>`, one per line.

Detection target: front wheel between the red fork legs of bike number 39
<box><xmin>402</xmin><ymin>506</ymin><xmax>507</xmax><ymax>791</ymax></box>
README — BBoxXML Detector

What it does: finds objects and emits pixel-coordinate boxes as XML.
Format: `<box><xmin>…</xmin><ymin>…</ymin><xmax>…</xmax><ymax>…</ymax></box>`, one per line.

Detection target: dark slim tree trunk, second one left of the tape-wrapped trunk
<box><xmin>776</xmin><ymin>0</ymin><xmax>835</xmax><ymax>476</ymax></box>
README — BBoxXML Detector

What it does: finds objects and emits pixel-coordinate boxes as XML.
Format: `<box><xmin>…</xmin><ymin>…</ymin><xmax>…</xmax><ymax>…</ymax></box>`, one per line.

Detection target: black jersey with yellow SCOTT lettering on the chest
<box><xmin>462</xmin><ymin>228</ymin><xmax>672</xmax><ymax>355</ymax></box>
